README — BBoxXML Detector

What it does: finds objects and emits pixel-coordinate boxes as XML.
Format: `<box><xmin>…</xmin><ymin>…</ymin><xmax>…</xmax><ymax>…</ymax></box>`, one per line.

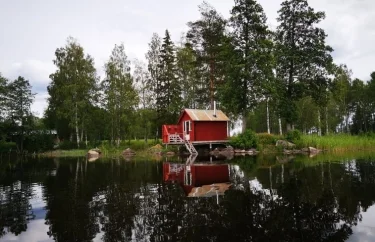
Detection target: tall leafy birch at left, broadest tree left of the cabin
<box><xmin>47</xmin><ymin>37</ymin><xmax>97</xmax><ymax>147</ymax></box>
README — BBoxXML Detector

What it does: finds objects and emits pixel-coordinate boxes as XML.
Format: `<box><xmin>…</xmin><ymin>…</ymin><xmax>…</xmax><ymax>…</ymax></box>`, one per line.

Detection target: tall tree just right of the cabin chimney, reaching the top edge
<box><xmin>223</xmin><ymin>0</ymin><xmax>273</xmax><ymax>131</ymax></box>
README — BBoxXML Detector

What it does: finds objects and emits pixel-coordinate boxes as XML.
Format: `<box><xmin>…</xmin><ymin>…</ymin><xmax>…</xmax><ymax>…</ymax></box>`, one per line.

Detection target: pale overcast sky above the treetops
<box><xmin>0</xmin><ymin>0</ymin><xmax>375</xmax><ymax>116</ymax></box>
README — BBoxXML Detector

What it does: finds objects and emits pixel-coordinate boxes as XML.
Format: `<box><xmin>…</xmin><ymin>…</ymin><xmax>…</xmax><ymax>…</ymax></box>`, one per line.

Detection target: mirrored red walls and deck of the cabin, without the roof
<box><xmin>163</xmin><ymin>163</ymin><xmax>229</xmax><ymax>196</ymax></box>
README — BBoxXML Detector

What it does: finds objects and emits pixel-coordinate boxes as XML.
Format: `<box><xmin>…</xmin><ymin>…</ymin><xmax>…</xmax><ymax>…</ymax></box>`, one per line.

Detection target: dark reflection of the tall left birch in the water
<box><xmin>44</xmin><ymin>159</ymin><xmax>99</xmax><ymax>241</ymax></box>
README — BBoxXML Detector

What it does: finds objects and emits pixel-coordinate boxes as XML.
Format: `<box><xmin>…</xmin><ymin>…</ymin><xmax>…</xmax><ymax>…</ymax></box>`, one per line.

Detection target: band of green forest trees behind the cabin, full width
<box><xmin>0</xmin><ymin>0</ymin><xmax>375</xmax><ymax>151</ymax></box>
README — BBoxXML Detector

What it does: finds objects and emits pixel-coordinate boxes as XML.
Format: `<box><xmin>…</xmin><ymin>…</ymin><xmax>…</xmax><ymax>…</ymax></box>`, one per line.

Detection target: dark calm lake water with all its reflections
<box><xmin>0</xmin><ymin>156</ymin><xmax>375</xmax><ymax>242</ymax></box>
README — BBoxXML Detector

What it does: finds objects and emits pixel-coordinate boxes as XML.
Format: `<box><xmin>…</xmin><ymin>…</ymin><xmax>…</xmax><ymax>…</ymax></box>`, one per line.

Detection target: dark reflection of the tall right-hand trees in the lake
<box><xmin>231</xmin><ymin>158</ymin><xmax>375</xmax><ymax>241</ymax></box>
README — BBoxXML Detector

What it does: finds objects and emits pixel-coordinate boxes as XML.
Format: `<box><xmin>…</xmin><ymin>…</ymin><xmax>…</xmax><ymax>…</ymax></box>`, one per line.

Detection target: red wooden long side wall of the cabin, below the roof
<box><xmin>192</xmin><ymin>121</ymin><xmax>228</xmax><ymax>141</ymax></box>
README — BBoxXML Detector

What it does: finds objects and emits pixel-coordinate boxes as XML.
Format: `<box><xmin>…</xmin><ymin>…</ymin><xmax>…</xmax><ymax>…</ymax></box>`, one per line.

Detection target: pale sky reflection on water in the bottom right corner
<box><xmin>348</xmin><ymin>206</ymin><xmax>375</xmax><ymax>242</ymax></box>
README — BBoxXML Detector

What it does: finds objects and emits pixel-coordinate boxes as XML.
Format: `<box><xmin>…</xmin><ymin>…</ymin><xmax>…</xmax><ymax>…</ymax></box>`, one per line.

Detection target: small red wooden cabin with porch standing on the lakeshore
<box><xmin>162</xmin><ymin>109</ymin><xmax>229</xmax><ymax>144</ymax></box>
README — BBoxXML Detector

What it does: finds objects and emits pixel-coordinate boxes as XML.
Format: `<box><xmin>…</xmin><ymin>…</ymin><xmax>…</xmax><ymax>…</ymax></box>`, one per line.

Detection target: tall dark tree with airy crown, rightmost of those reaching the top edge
<box><xmin>276</xmin><ymin>0</ymin><xmax>332</xmax><ymax>130</ymax></box>
